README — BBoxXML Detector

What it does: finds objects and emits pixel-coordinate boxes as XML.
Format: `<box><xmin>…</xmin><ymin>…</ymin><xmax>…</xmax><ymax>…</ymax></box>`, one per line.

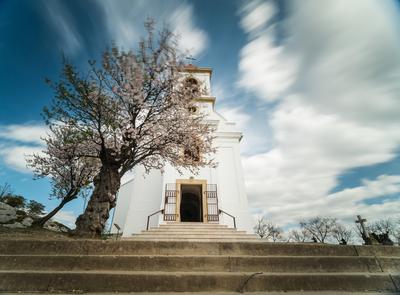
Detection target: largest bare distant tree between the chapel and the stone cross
<box><xmin>300</xmin><ymin>216</ymin><xmax>336</xmax><ymax>243</ymax></box>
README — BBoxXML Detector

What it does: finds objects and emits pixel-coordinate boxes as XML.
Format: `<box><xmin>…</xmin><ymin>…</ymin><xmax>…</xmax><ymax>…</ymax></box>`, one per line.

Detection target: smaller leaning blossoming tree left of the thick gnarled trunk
<box><xmin>27</xmin><ymin>124</ymin><xmax>99</xmax><ymax>226</ymax></box>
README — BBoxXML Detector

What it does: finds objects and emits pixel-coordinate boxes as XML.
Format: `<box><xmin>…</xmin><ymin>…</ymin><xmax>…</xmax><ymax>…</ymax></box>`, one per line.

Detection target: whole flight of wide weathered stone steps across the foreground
<box><xmin>0</xmin><ymin>239</ymin><xmax>400</xmax><ymax>294</ymax></box>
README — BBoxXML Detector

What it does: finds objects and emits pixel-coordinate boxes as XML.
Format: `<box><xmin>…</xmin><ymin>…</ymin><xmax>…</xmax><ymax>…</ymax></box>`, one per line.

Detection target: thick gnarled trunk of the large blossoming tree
<box><xmin>75</xmin><ymin>163</ymin><xmax>121</xmax><ymax>237</ymax></box>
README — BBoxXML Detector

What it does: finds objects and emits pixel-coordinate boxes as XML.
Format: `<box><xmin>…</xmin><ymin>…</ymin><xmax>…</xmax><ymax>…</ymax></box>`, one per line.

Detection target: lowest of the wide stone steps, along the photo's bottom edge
<box><xmin>0</xmin><ymin>270</ymin><xmax>400</xmax><ymax>292</ymax></box>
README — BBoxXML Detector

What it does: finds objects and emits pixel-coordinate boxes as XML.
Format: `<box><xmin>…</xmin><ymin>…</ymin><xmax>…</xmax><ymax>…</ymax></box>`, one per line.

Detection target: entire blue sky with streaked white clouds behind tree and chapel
<box><xmin>0</xmin><ymin>0</ymin><xmax>400</xmax><ymax>229</ymax></box>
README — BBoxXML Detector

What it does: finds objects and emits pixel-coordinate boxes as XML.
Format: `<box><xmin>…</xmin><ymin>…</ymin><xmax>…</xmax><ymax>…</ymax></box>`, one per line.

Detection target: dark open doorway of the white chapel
<box><xmin>180</xmin><ymin>184</ymin><xmax>203</xmax><ymax>222</ymax></box>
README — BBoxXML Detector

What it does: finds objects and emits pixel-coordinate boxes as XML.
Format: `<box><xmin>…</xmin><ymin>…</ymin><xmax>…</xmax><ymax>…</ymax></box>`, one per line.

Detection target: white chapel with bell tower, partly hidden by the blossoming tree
<box><xmin>112</xmin><ymin>65</ymin><xmax>253</xmax><ymax>237</ymax></box>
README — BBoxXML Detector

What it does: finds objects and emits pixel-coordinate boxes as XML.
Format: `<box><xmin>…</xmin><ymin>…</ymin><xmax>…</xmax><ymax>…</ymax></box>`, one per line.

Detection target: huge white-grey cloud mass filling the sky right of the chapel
<box><xmin>239</xmin><ymin>0</ymin><xmax>400</xmax><ymax>228</ymax></box>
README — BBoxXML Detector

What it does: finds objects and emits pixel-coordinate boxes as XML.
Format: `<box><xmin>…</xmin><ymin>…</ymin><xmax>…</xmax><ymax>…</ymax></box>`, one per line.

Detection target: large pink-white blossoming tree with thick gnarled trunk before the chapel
<box><xmin>44</xmin><ymin>21</ymin><xmax>215</xmax><ymax>236</ymax></box>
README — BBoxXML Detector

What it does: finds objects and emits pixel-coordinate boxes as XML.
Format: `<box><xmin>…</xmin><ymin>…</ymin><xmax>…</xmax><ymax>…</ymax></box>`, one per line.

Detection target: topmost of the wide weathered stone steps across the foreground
<box><xmin>0</xmin><ymin>239</ymin><xmax>400</xmax><ymax>257</ymax></box>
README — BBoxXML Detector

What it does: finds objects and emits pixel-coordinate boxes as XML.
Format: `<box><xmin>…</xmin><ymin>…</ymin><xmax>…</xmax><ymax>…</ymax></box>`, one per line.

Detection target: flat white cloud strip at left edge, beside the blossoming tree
<box><xmin>0</xmin><ymin>124</ymin><xmax>48</xmax><ymax>144</ymax></box>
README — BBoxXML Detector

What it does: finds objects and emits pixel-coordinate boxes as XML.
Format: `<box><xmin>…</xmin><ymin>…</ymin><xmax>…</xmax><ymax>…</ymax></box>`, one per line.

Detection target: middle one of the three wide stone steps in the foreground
<box><xmin>0</xmin><ymin>255</ymin><xmax>400</xmax><ymax>273</ymax></box>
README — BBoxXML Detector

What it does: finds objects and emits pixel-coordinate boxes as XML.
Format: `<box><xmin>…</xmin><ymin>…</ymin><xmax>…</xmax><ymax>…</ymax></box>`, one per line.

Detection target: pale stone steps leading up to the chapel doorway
<box><xmin>125</xmin><ymin>222</ymin><xmax>259</xmax><ymax>242</ymax></box>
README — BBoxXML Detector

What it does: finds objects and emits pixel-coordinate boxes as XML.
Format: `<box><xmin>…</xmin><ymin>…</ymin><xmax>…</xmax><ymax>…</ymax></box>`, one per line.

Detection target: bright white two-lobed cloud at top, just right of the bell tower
<box><xmin>238</xmin><ymin>1</ymin><xmax>297</xmax><ymax>101</ymax></box>
